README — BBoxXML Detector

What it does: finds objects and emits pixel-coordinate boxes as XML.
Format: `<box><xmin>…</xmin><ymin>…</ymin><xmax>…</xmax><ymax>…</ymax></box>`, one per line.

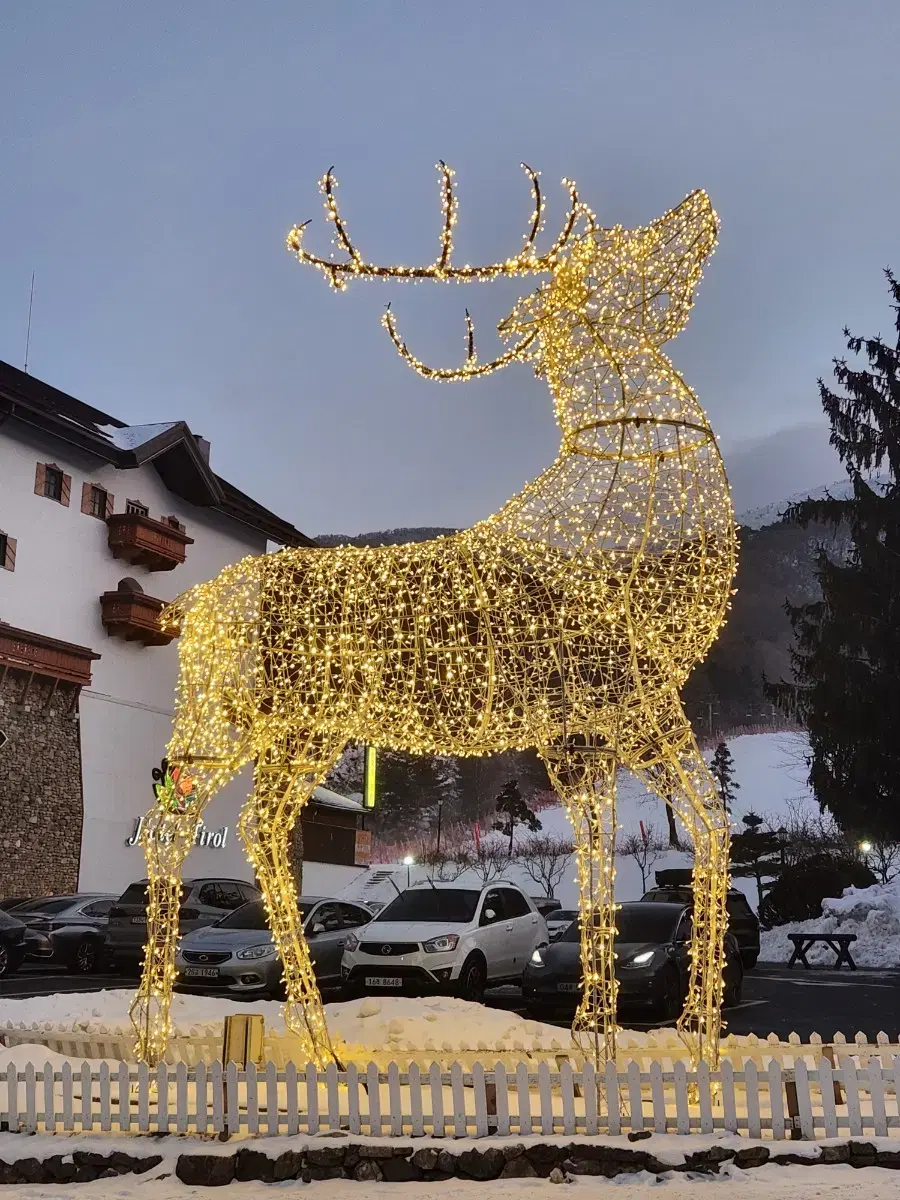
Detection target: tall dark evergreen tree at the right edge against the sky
<box><xmin>769</xmin><ymin>271</ymin><xmax>900</xmax><ymax>839</ymax></box>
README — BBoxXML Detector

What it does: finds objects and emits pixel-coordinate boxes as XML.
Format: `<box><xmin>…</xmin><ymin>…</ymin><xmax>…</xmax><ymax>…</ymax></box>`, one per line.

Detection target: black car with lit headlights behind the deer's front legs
<box><xmin>522</xmin><ymin>902</ymin><xmax>744</xmax><ymax>1020</ymax></box>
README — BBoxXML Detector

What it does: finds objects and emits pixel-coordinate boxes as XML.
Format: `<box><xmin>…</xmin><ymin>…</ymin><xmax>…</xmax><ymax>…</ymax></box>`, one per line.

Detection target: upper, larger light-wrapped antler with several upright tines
<box><xmin>287</xmin><ymin>162</ymin><xmax>593</xmax><ymax>289</ymax></box>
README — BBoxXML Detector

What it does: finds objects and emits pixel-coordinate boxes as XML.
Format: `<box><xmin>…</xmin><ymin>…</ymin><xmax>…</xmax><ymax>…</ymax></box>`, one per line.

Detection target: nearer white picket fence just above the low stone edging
<box><xmin>0</xmin><ymin>1055</ymin><xmax>900</xmax><ymax>1139</ymax></box>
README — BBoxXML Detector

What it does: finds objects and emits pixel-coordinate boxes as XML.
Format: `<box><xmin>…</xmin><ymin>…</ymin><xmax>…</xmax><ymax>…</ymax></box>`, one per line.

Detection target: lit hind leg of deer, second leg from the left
<box><xmin>240</xmin><ymin>739</ymin><xmax>343</xmax><ymax>1067</ymax></box>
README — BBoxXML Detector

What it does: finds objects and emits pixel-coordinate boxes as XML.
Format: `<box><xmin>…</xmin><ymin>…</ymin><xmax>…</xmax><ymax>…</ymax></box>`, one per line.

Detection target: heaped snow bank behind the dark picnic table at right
<box><xmin>760</xmin><ymin>876</ymin><xmax>900</xmax><ymax>967</ymax></box>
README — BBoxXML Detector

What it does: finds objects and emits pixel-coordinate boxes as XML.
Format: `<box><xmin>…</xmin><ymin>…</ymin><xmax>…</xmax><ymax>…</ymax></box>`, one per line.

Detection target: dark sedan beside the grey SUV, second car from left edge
<box><xmin>11</xmin><ymin>893</ymin><xmax>115</xmax><ymax>974</ymax></box>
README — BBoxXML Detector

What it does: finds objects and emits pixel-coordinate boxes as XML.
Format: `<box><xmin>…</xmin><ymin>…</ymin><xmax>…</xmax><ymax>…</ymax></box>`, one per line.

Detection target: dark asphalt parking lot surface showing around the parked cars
<box><xmin>0</xmin><ymin>965</ymin><xmax>900</xmax><ymax>1040</ymax></box>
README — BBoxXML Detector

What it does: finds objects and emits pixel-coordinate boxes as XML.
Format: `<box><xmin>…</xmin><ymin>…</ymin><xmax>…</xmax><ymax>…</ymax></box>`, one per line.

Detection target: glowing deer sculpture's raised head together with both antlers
<box><xmin>287</xmin><ymin>162</ymin><xmax>718</xmax><ymax>393</ymax></box>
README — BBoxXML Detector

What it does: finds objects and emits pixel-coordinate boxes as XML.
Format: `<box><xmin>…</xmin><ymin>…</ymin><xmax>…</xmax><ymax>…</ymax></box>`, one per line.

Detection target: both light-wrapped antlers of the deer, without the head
<box><xmin>287</xmin><ymin>162</ymin><xmax>594</xmax><ymax>383</ymax></box>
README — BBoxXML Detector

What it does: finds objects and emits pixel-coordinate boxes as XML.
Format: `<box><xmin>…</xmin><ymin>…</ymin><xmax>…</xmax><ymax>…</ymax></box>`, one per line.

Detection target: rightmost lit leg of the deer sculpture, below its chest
<box><xmin>632</xmin><ymin>721</ymin><xmax>730</xmax><ymax>1068</ymax></box>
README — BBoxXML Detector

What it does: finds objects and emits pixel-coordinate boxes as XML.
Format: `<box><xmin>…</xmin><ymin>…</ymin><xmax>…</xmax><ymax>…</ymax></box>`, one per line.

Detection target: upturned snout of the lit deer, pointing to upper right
<box><xmin>637</xmin><ymin>191</ymin><xmax>719</xmax><ymax>346</ymax></box>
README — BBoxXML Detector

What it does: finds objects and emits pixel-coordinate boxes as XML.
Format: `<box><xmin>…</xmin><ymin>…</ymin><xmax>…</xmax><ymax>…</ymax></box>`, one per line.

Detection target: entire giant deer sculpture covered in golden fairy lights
<box><xmin>132</xmin><ymin>163</ymin><xmax>736</xmax><ymax>1064</ymax></box>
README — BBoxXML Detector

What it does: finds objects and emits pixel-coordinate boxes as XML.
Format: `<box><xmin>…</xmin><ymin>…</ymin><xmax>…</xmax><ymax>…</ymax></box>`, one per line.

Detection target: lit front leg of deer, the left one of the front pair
<box><xmin>546</xmin><ymin>750</ymin><xmax>618</xmax><ymax>1067</ymax></box>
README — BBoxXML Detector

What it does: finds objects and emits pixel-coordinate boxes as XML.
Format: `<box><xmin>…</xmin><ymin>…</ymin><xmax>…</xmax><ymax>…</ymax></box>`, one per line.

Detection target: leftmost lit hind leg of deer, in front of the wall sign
<box><xmin>130</xmin><ymin>752</ymin><xmax>250</xmax><ymax>1066</ymax></box>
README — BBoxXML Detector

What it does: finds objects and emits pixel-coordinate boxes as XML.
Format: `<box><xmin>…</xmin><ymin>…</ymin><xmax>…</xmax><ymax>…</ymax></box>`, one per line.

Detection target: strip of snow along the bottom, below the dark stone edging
<box><xmin>2</xmin><ymin>1163</ymin><xmax>900</xmax><ymax>1200</ymax></box>
